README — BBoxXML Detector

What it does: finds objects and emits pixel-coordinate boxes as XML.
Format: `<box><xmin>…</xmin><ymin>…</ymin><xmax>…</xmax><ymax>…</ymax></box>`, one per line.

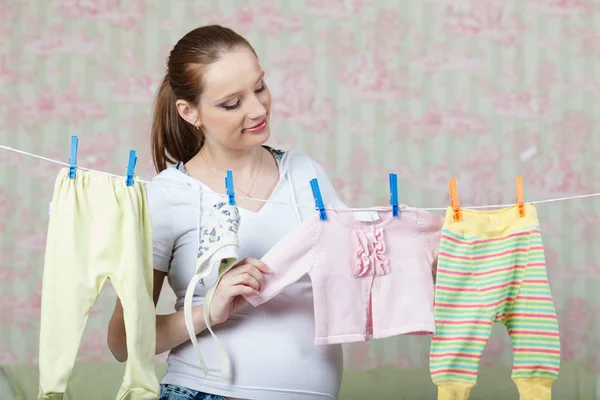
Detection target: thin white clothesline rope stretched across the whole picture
<box><xmin>0</xmin><ymin>145</ymin><xmax>600</xmax><ymax>211</ymax></box>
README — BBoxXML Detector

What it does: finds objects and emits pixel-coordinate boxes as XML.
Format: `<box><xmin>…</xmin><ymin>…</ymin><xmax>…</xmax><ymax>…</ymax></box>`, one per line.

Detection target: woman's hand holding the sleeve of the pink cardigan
<box><xmin>209</xmin><ymin>257</ymin><xmax>271</xmax><ymax>325</ymax></box>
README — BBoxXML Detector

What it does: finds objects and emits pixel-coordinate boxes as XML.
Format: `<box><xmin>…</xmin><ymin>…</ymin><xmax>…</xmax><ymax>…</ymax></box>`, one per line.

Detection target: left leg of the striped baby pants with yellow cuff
<box><xmin>429</xmin><ymin>229</ymin><xmax>492</xmax><ymax>400</ymax></box>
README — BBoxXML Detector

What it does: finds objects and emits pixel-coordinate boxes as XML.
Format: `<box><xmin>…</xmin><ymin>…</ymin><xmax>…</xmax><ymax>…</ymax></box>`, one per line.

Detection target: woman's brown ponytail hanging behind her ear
<box><xmin>151</xmin><ymin>76</ymin><xmax>204</xmax><ymax>173</ymax></box>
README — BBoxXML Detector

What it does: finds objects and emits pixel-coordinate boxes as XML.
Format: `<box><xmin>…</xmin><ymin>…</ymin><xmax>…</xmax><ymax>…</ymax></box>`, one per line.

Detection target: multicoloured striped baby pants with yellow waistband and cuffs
<box><xmin>430</xmin><ymin>205</ymin><xmax>560</xmax><ymax>400</ymax></box>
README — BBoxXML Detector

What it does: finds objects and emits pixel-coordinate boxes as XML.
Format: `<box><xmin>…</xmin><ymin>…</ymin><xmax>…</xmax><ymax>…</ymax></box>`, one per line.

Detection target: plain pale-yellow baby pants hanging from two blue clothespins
<box><xmin>38</xmin><ymin>168</ymin><xmax>159</xmax><ymax>400</ymax></box>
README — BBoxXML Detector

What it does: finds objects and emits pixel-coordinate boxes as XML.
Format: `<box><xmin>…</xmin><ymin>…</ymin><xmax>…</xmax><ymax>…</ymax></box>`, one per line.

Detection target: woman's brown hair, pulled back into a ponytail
<box><xmin>151</xmin><ymin>25</ymin><xmax>256</xmax><ymax>172</ymax></box>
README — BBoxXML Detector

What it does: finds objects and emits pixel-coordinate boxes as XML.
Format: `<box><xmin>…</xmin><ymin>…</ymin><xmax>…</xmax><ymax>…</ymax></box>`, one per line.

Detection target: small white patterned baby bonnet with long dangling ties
<box><xmin>183</xmin><ymin>200</ymin><xmax>240</xmax><ymax>380</ymax></box>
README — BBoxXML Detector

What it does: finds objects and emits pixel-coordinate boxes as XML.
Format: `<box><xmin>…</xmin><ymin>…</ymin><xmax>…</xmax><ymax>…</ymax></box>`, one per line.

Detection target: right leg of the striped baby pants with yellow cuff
<box><xmin>504</xmin><ymin>228</ymin><xmax>560</xmax><ymax>400</ymax></box>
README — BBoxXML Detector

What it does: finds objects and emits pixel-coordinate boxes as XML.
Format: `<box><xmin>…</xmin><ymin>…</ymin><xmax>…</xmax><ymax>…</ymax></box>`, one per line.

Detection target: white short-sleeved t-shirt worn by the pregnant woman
<box><xmin>147</xmin><ymin>149</ymin><xmax>345</xmax><ymax>400</ymax></box>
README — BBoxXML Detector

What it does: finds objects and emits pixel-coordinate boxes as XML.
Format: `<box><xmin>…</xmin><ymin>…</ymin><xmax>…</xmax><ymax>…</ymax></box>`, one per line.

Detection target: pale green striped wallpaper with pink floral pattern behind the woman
<box><xmin>0</xmin><ymin>0</ymin><xmax>600</xmax><ymax>378</ymax></box>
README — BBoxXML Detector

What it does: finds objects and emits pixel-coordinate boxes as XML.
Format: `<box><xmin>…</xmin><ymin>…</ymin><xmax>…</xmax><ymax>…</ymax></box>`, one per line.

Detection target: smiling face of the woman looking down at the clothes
<box><xmin>197</xmin><ymin>47</ymin><xmax>271</xmax><ymax>150</ymax></box>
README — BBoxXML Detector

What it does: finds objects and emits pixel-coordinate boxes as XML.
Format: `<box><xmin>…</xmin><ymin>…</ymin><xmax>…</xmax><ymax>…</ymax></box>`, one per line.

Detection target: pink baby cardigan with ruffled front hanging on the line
<box><xmin>246</xmin><ymin>206</ymin><xmax>443</xmax><ymax>344</ymax></box>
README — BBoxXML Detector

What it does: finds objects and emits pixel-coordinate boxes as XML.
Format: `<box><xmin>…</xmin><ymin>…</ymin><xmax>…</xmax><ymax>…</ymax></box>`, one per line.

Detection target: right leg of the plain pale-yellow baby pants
<box><xmin>110</xmin><ymin>180</ymin><xmax>160</xmax><ymax>400</ymax></box>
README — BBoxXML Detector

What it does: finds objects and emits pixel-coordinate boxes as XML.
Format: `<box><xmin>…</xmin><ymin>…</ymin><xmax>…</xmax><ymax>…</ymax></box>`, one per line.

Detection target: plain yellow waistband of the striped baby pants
<box><xmin>443</xmin><ymin>204</ymin><xmax>540</xmax><ymax>238</ymax></box>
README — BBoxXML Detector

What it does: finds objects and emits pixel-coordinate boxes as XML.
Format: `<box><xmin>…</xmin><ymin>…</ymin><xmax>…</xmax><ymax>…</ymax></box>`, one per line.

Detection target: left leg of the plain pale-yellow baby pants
<box><xmin>38</xmin><ymin>169</ymin><xmax>106</xmax><ymax>400</ymax></box>
